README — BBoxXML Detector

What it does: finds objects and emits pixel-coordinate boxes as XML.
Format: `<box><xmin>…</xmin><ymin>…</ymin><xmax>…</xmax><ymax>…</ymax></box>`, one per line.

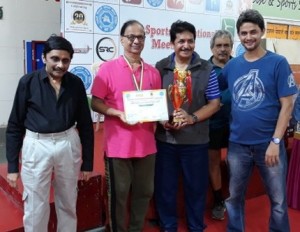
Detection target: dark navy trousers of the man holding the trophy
<box><xmin>154</xmin><ymin>141</ymin><xmax>208</xmax><ymax>232</ymax></box>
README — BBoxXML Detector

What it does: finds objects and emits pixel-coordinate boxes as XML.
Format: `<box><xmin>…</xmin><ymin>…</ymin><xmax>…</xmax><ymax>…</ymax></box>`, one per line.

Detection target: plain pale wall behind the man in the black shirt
<box><xmin>0</xmin><ymin>0</ymin><xmax>60</xmax><ymax>127</ymax></box>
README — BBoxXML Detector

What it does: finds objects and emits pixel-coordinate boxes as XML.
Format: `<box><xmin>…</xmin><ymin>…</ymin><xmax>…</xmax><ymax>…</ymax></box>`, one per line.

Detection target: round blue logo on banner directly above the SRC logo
<box><xmin>95</xmin><ymin>5</ymin><xmax>118</xmax><ymax>32</ymax></box>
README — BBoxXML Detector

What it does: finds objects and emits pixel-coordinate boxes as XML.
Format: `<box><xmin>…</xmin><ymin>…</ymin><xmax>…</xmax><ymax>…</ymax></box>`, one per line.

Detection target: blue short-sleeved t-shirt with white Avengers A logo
<box><xmin>220</xmin><ymin>51</ymin><xmax>297</xmax><ymax>145</ymax></box>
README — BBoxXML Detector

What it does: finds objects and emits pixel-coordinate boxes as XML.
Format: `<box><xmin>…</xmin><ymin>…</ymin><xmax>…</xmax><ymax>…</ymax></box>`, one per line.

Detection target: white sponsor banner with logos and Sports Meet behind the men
<box><xmin>61</xmin><ymin>0</ymin><xmax>253</xmax><ymax>121</ymax></box>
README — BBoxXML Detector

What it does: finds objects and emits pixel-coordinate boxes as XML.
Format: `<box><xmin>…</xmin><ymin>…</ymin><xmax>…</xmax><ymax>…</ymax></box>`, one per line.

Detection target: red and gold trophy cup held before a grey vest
<box><xmin>168</xmin><ymin>68</ymin><xmax>192</xmax><ymax>123</ymax></box>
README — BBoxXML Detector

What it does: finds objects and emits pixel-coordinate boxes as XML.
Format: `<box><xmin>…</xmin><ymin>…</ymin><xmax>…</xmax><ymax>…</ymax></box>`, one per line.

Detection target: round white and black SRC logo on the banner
<box><xmin>96</xmin><ymin>37</ymin><xmax>117</xmax><ymax>61</ymax></box>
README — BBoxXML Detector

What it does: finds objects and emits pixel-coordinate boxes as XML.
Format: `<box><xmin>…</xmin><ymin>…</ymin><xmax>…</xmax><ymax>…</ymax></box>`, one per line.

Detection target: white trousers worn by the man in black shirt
<box><xmin>21</xmin><ymin>127</ymin><xmax>82</xmax><ymax>232</ymax></box>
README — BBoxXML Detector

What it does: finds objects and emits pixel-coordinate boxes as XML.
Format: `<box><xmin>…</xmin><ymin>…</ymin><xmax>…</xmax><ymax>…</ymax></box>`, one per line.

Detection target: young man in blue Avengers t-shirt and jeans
<box><xmin>220</xmin><ymin>10</ymin><xmax>297</xmax><ymax>232</ymax></box>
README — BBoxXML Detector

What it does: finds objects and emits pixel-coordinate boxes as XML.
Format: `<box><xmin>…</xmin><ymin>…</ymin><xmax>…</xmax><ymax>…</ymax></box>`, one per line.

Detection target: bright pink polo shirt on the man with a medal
<box><xmin>91</xmin><ymin>56</ymin><xmax>161</xmax><ymax>158</ymax></box>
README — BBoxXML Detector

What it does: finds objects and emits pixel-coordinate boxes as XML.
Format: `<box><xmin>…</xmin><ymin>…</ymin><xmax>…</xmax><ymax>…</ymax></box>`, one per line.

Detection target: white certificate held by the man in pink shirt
<box><xmin>123</xmin><ymin>89</ymin><xmax>169</xmax><ymax>122</ymax></box>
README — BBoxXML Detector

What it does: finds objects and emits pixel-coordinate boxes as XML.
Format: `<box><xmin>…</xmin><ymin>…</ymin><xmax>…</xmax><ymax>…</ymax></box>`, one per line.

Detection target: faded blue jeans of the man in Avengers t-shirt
<box><xmin>225</xmin><ymin>142</ymin><xmax>290</xmax><ymax>232</ymax></box>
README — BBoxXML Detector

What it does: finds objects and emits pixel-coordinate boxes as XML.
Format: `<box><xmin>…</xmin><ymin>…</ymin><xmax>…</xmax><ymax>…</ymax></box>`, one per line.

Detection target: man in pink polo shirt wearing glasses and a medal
<box><xmin>92</xmin><ymin>20</ymin><xmax>161</xmax><ymax>232</ymax></box>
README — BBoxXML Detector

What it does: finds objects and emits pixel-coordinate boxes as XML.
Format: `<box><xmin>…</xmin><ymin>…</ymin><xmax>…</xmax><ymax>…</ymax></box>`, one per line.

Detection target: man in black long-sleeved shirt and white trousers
<box><xmin>6</xmin><ymin>36</ymin><xmax>94</xmax><ymax>232</ymax></box>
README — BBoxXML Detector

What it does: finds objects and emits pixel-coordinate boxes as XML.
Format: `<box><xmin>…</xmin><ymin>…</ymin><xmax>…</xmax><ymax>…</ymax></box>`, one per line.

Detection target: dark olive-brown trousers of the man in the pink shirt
<box><xmin>105</xmin><ymin>155</ymin><xmax>155</xmax><ymax>232</ymax></box>
